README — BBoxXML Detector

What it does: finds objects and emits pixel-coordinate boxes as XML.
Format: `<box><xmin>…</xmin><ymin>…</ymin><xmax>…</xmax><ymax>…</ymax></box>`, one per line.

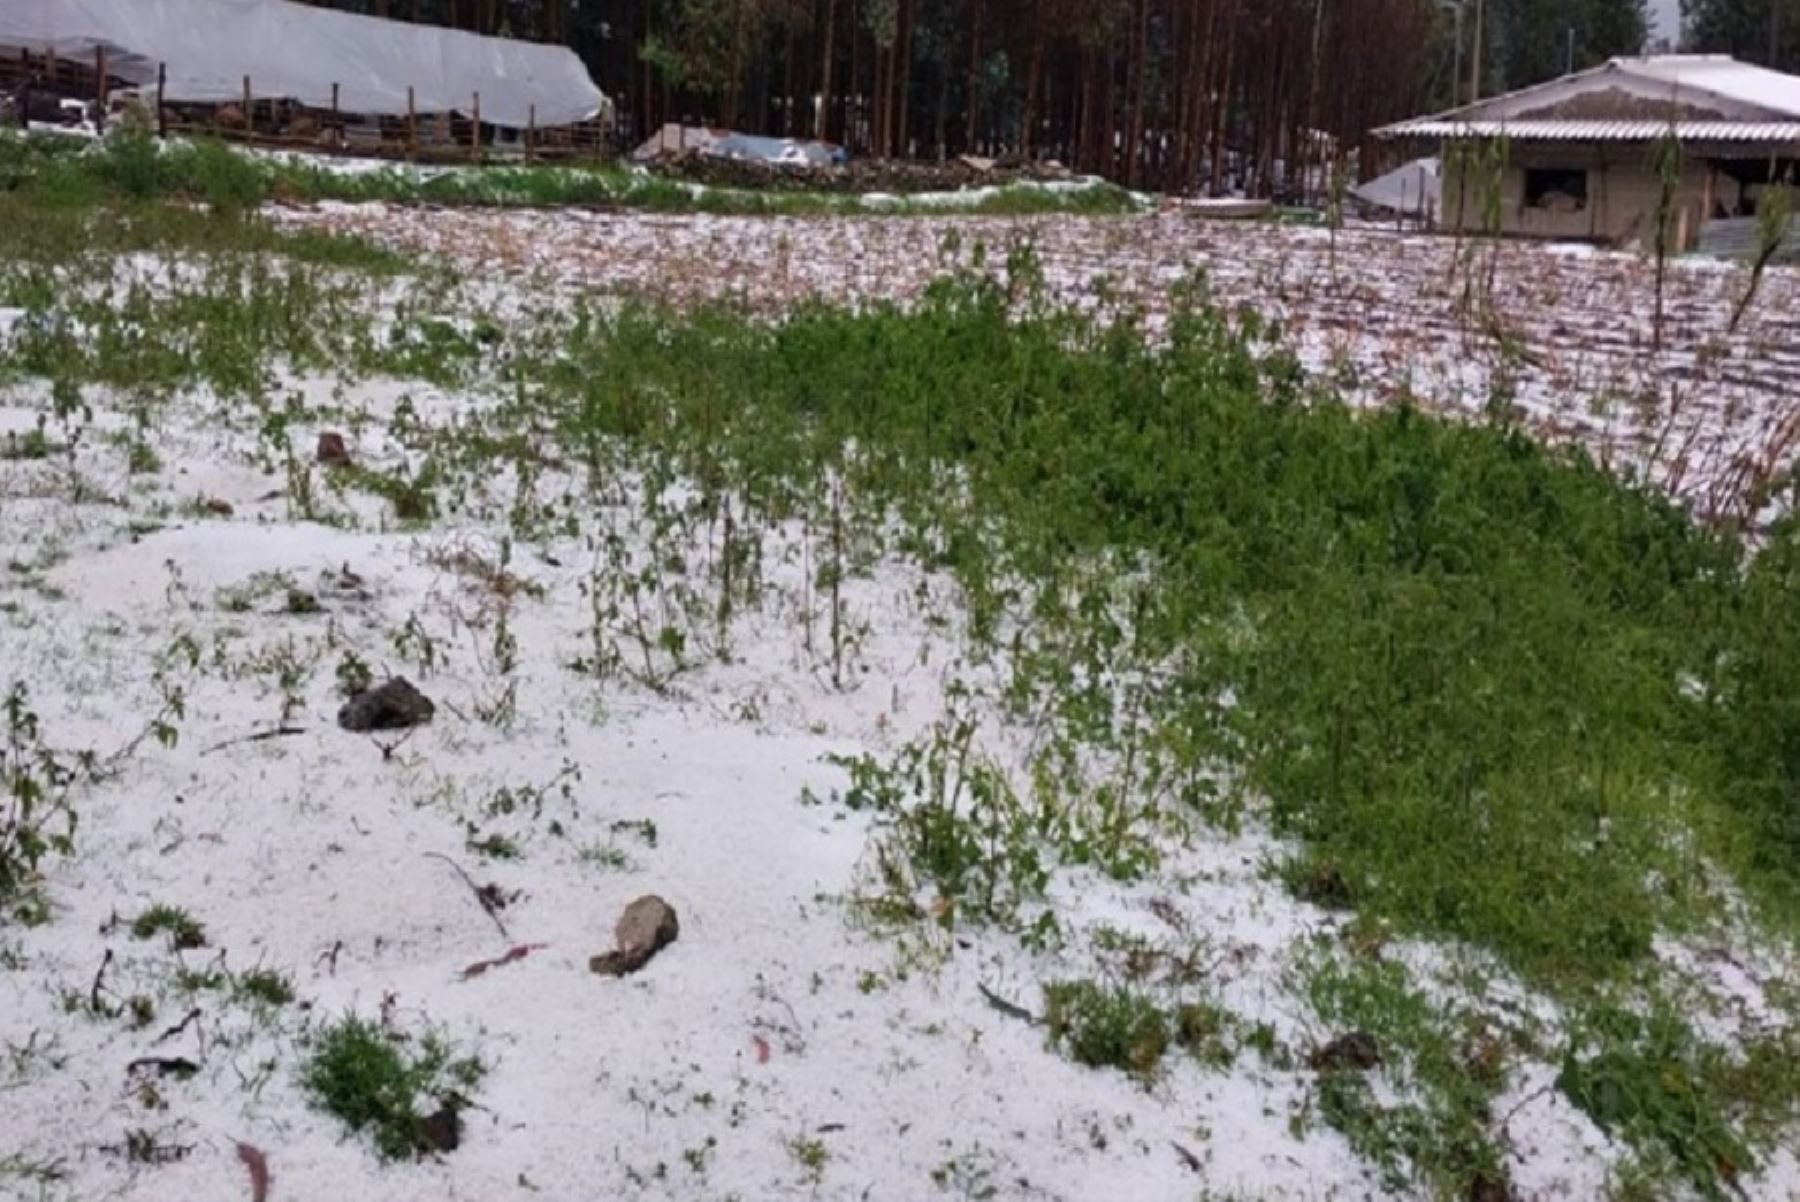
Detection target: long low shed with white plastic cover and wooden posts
<box><xmin>0</xmin><ymin>0</ymin><xmax>610</xmax><ymax>153</ymax></box>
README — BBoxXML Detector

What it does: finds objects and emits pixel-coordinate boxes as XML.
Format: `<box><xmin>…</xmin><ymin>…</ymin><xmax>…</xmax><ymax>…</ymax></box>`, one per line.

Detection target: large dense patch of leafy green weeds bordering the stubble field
<box><xmin>524</xmin><ymin>262</ymin><xmax>1796</xmax><ymax>981</ymax></box>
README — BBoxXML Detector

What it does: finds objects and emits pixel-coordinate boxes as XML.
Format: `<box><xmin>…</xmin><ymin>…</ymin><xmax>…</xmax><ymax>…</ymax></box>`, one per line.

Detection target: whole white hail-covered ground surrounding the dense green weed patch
<box><xmin>0</xmin><ymin>183</ymin><xmax>1800</xmax><ymax>1202</ymax></box>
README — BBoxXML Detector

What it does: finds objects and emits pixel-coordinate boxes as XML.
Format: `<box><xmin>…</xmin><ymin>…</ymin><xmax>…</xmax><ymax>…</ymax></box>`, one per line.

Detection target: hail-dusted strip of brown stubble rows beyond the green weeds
<box><xmin>274</xmin><ymin>203</ymin><xmax>1800</xmax><ymax>525</ymax></box>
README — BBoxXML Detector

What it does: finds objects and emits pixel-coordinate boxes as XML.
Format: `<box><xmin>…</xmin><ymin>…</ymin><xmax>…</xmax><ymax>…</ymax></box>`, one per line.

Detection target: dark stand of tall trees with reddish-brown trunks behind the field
<box><xmin>284</xmin><ymin>0</ymin><xmax>1800</xmax><ymax>194</ymax></box>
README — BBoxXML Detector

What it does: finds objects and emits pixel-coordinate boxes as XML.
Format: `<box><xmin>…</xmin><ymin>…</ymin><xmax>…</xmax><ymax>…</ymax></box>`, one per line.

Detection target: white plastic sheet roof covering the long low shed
<box><xmin>0</xmin><ymin>0</ymin><xmax>607</xmax><ymax>128</ymax></box>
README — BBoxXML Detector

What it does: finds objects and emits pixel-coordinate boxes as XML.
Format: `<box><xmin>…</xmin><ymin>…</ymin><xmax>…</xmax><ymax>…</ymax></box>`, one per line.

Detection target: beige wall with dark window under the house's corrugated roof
<box><xmin>1444</xmin><ymin>144</ymin><xmax>1739</xmax><ymax>248</ymax></box>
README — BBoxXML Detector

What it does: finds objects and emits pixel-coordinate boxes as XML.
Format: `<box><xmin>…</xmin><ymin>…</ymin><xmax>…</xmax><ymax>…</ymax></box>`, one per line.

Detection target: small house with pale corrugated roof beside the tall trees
<box><xmin>1375</xmin><ymin>54</ymin><xmax>1800</xmax><ymax>250</ymax></box>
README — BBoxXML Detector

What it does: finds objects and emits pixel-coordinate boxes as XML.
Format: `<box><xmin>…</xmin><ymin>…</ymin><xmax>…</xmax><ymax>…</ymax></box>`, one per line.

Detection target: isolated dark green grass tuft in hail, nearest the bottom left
<box><xmin>301</xmin><ymin>1015</ymin><xmax>486</xmax><ymax>1161</ymax></box>
